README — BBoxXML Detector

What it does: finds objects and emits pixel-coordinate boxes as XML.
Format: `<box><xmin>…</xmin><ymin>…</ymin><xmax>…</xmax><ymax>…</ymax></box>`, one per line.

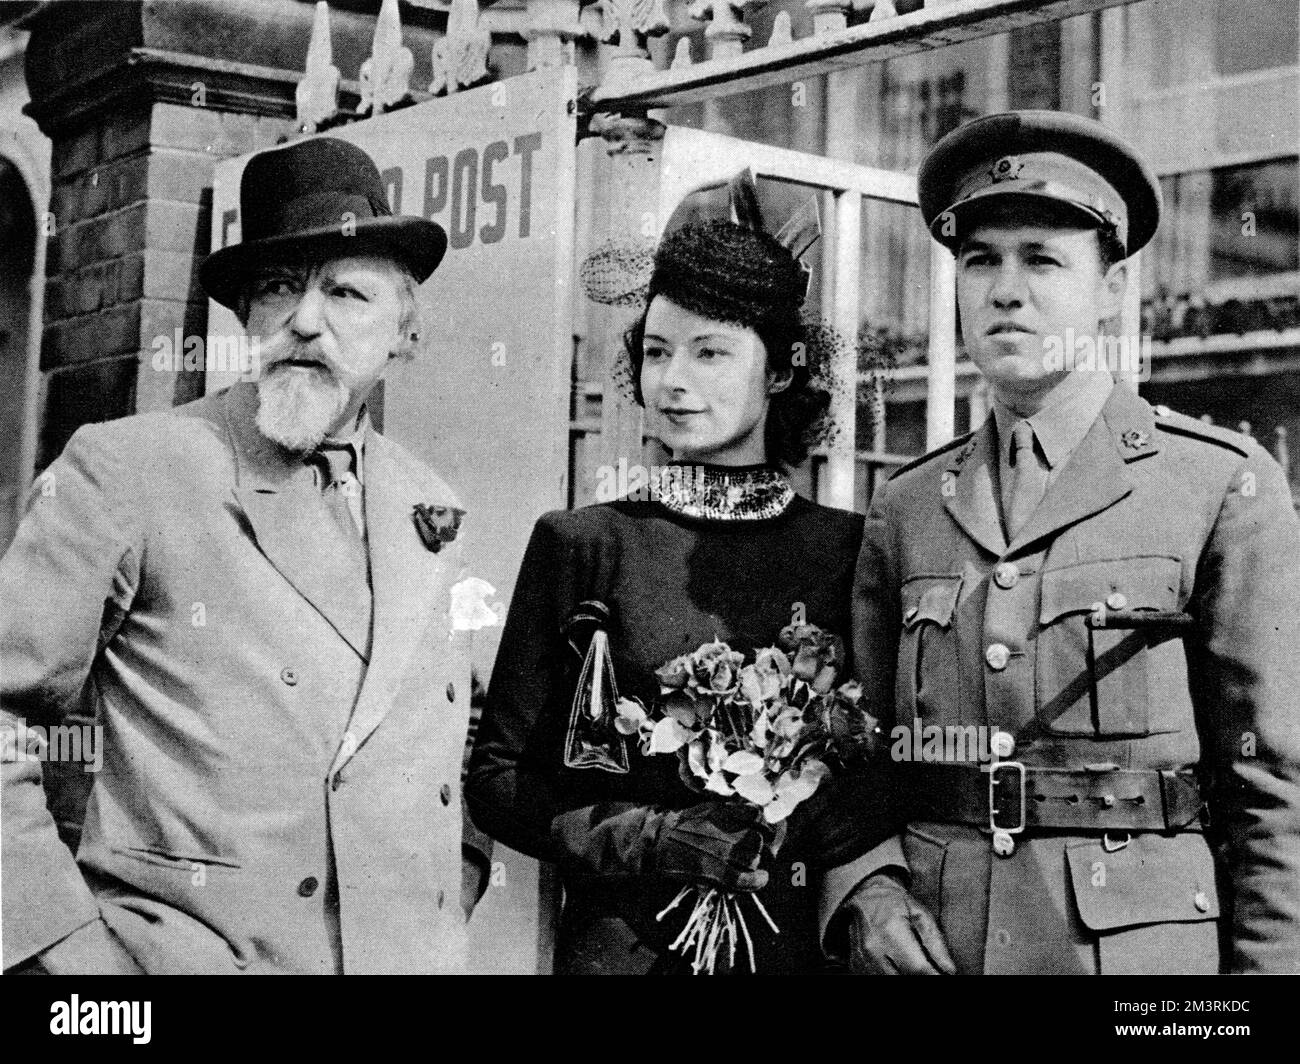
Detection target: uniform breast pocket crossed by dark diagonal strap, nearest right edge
<box><xmin>1035</xmin><ymin>557</ymin><xmax>1187</xmax><ymax>739</ymax></box>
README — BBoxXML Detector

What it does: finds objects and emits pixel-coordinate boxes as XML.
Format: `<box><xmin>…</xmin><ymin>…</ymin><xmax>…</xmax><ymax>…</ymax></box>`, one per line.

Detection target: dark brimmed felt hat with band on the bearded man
<box><xmin>199</xmin><ymin>137</ymin><xmax>447</xmax><ymax>308</ymax></box>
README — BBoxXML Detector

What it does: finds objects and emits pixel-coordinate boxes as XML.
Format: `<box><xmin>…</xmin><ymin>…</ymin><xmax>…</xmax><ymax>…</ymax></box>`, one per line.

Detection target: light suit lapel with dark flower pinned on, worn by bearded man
<box><xmin>334</xmin><ymin>431</ymin><xmax>455</xmax><ymax>769</ymax></box>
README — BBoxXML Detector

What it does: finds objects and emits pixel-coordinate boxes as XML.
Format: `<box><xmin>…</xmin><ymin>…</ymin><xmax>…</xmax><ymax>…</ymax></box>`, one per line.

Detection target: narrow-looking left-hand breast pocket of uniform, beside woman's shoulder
<box><xmin>894</xmin><ymin>574</ymin><xmax>962</xmax><ymax>723</ymax></box>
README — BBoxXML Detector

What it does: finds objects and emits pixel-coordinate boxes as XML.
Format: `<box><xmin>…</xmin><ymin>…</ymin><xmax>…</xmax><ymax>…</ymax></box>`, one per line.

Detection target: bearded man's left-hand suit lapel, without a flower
<box><xmin>225</xmin><ymin>382</ymin><xmax>371</xmax><ymax>658</ymax></box>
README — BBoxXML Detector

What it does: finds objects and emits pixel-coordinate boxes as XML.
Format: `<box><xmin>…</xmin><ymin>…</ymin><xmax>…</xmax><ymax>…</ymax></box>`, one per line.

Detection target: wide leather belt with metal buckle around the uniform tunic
<box><xmin>902</xmin><ymin>761</ymin><xmax>1203</xmax><ymax>832</ymax></box>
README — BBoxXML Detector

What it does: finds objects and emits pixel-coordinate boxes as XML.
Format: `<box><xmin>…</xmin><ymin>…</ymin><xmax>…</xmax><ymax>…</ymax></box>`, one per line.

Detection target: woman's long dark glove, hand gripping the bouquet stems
<box><xmin>551</xmin><ymin>801</ymin><xmax>770</xmax><ymax>891</ymax></box>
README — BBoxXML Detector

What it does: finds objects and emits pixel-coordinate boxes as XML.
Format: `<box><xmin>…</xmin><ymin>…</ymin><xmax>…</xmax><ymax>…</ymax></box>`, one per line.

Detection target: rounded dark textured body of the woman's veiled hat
<box><xmin>646</xmin><ymin>221</ymin><xmax>809</xmax><ymax>329</ymax></box>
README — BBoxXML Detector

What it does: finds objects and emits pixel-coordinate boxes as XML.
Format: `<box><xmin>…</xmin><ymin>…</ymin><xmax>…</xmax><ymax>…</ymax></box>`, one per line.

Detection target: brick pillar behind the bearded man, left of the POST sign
<box><xmin>38</xmin><ymin>103</ymin><xmax>293</xmax><ymax>467</ymax></box>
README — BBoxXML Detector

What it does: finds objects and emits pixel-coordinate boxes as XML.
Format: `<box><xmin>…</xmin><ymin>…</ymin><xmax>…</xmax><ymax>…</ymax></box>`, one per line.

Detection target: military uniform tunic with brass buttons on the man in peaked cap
<box><xmin>836</xmin><ymin>388</ymin><xmax>1300</xmax><ymax>973</ymax></box>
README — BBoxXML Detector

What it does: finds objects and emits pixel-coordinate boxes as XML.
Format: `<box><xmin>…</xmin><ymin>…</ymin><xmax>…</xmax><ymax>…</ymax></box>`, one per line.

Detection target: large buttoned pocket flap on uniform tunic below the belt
<box><xmin>1065</xmin><ymin>834</ymin><xmax>1219</xmax><ymax>931</ymax></box>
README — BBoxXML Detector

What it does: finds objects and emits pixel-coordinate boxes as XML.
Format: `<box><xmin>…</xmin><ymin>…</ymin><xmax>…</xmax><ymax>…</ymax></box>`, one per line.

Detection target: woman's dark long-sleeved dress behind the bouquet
<box><xmin>467</xmin><ymin>470</ymin><xmax>888</xmax><ymax>973</ymax></box>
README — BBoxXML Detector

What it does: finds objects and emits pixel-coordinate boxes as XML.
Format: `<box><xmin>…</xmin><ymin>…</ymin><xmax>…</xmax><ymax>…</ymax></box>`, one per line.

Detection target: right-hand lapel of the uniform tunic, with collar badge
<box><xmin>1011</xmin><ymin>385</ymin><xmax>1157</xmax><ymax>549</ymax></box>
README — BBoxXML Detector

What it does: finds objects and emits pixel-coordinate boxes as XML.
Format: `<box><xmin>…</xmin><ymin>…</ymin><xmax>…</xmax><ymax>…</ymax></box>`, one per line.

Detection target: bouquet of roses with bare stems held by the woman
<box><xmin>615</xmin><ymin>624</ymin><xmax>879</xmax><ymax>974</ymax></box>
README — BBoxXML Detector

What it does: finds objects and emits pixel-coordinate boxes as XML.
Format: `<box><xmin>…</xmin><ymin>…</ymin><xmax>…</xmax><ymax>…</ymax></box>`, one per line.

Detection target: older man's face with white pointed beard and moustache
<box><xmin>244</xmin><ymin>255</ymin><xmax>410</xmax><ymax>451</ymax></box>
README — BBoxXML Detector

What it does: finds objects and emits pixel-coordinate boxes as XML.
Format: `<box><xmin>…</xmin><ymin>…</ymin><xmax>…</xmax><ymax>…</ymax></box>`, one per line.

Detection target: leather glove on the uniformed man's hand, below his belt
<box><xmin>841</xmin><ymin>871</ymin><xmax>957</xmax><ymax>976</ymax></box>
